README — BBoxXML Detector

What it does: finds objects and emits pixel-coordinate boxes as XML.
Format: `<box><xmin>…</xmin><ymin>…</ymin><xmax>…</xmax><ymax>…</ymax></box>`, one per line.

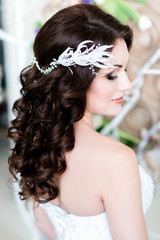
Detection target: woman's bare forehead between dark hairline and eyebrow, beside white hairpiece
<box><xmin>111</xmin><ymin>39</ymin><xmax>129</xmax><ymax>66</ymax></box>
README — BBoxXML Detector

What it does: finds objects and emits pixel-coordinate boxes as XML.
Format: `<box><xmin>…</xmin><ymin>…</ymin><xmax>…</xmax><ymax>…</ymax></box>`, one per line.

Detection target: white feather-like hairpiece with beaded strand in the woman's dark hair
<box><xmin>31</xmin><ymin>40</ymin><xmax>115</xmax><ymax>75</ymax></box>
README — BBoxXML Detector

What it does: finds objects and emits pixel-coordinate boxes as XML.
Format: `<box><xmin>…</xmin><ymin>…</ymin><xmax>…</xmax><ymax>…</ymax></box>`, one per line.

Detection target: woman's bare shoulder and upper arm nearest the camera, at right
<box><xmin>96</xmin><ymin>134</ymin><xmax>148</xmax><ymax>240</ymax></box>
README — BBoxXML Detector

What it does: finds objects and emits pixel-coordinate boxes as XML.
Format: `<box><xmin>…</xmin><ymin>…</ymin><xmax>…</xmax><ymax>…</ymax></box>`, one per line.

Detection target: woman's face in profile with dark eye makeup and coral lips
<box><xmin>86</xmin><ymin>39</ymin><xmax>131</xmax><ymax>116</ymax></box>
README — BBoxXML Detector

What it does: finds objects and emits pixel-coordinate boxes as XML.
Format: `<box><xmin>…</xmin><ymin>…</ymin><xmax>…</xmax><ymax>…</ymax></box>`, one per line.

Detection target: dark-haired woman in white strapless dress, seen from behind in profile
<box><xmin>8</xmin><ymin>4</ymin><xmax>153</xmax><ymax>240</ymax></box>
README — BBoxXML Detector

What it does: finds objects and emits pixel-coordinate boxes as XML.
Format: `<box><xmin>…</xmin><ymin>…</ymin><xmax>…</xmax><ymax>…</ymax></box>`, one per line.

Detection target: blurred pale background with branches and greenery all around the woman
<box><xmin>0</xmin><ymin>0</ymin><xmax>160</xmax><ymax>240</ymax></box>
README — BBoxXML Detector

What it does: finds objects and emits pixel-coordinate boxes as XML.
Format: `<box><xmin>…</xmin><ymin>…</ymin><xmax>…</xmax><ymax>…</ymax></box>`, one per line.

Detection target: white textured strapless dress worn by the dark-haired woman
<box><xmin>40</xmin><ymin>165</ymin><xmax>154</xmax><ymax>240</ymax></box>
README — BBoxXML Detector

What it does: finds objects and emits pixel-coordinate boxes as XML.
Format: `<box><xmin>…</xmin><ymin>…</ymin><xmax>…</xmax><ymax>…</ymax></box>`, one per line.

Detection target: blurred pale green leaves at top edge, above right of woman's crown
<box><xmin>101</xmin><ymin>0</ymin><xmax>147</xmax><ymax>23</ymax></box>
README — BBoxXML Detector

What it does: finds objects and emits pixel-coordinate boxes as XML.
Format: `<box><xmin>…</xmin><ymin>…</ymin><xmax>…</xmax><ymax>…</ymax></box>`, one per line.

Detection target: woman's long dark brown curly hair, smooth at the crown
<box><xmin>8</xmin><ymin>4</ymin><xmax>132</xmax><ymax>202</ymax></box>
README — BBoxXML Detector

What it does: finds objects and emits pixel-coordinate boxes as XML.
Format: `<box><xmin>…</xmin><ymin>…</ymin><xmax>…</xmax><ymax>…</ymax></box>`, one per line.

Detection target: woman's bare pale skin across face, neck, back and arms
<box><xmin>35</xmin><ymin>40</ymin><xmax>148</xmax><ymax>240</ymax></box>
